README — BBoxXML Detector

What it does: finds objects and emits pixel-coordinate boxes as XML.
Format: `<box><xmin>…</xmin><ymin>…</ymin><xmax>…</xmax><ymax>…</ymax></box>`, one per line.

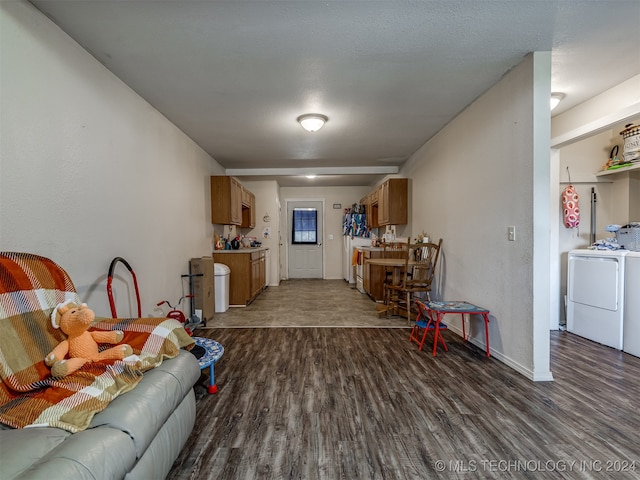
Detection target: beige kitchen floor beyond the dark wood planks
<box><xmin>200</xmin><ymin>279</ymin><xmax>408</xmax><ymax>328</ymax></box>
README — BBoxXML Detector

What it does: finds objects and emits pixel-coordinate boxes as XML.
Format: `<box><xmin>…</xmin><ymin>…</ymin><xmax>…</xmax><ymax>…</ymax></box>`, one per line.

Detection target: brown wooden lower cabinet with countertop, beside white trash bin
<box><xmin>213</xmin><ymin>250</ymin><xmax>267</xmax><ymax>305</ymax></box>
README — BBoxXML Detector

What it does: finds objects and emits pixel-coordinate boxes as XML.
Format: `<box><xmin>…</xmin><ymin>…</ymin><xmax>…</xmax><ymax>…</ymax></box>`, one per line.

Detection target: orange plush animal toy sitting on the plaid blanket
<box><xmin>44</xmin><ymin>300</ymin><xmax>133</xmax><ymax>377</ymax></box>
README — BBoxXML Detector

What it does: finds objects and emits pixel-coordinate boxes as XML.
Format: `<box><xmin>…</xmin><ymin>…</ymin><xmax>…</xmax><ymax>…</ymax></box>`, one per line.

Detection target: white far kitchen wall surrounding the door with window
<box><xmin>280</xmin><ymin>187</ymin><xmax>373</xmax><ymax>280</ymax></box>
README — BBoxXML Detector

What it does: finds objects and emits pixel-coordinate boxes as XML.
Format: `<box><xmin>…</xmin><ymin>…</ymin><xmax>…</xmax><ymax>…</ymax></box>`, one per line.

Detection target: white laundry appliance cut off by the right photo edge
<box><xmin>623</xmin><ymin>252</ymin><xmax>640</xmax><ymax>357</ymax></box>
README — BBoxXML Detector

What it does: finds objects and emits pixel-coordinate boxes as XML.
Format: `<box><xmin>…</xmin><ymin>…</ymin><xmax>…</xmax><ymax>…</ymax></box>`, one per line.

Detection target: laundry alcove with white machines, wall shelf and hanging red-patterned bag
<box><xmin>555</xmin><ymin>118</ymin><xmax>640</xmax><ymax>356</ymax></box>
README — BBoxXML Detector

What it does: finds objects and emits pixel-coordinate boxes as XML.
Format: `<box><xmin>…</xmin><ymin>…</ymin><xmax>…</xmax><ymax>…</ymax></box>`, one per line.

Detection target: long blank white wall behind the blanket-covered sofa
<box><xmin>0</xmin><ymin>1</ymin><xmax>224</xmax><ymax>316</ymax></box>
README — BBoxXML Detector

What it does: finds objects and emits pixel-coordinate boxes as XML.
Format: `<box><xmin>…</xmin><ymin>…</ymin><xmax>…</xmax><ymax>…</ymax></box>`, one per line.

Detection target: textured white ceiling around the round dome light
<box><xmin>32</xmin><ymin>0</ymin><xmax>640</xmax><ymax>186</ymax></box>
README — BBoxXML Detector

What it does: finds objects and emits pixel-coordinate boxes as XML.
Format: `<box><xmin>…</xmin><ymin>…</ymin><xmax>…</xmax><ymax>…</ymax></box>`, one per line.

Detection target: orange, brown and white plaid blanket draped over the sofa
<box><xmin>0</xmin><ymin>252</ymin><xmax>194</xmax><ymax>432</ymax></box>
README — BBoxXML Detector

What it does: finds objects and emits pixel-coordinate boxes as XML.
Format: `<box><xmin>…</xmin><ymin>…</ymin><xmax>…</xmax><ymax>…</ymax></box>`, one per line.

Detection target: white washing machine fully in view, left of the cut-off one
<box><xmin>567</xmin><ymin>249</ymin><xmax>629</xmax><ymax>350</ymax></box>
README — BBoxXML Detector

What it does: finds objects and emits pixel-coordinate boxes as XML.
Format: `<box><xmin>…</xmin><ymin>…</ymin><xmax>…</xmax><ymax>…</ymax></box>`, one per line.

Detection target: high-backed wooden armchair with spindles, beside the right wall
<box><xmin>387</xmin><ymin>239</ymin><xmax>442</xmax><ymax>322</ymax></box>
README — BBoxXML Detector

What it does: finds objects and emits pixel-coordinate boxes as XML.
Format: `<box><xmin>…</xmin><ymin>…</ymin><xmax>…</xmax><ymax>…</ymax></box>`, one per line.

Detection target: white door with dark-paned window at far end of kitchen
<box><xmin>286</xmin><ymin>200</ymin><xmax>324</xmax><ymax>278</ymax></box>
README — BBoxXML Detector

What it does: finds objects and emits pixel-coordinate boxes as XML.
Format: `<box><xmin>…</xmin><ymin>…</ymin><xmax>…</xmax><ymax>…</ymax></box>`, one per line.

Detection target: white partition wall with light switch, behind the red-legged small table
<box><xmin>400</xmin><ymin>52</ymin><xmax>552</xmax><ymax>380</ymax></box>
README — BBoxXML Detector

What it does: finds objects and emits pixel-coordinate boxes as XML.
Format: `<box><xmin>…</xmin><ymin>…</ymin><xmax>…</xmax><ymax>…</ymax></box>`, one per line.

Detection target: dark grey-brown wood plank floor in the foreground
<box><xmin>168</xmin><ymin>282</ymin><xmax>640</xmax><ymax>480</ymax></box>
